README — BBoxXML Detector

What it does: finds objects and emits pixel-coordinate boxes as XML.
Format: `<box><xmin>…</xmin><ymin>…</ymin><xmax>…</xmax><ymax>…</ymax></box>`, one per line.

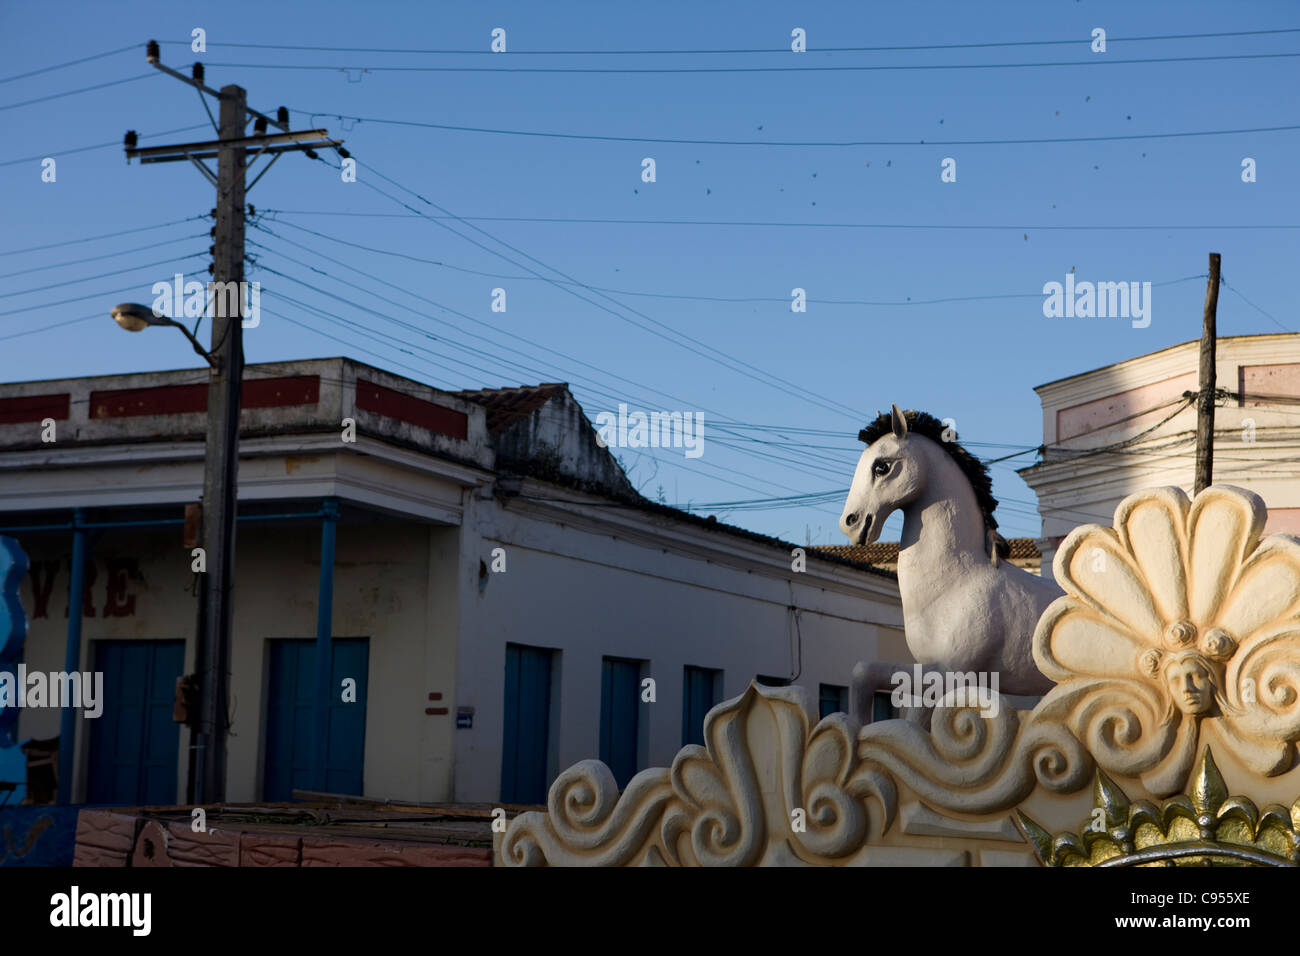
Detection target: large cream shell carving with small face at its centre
<box><xmin>1034</xmin><ymin>485</ymin><xmax>1300</xmax><ymax>795</ymax></box>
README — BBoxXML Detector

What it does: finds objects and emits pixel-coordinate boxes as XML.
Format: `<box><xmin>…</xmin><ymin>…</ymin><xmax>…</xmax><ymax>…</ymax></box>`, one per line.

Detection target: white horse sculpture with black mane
<box><xmin>840</xmin><ymin>406</ymin><xmax>1063</xmax><ymax>721</ymax></box>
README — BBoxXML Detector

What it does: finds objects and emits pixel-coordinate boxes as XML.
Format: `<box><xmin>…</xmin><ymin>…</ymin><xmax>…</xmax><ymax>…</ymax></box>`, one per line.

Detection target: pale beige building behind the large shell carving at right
<box><xmin>1019</xmin><ymin>333</ymin><xmax>1300</xmax><ymax>575</ymax></box>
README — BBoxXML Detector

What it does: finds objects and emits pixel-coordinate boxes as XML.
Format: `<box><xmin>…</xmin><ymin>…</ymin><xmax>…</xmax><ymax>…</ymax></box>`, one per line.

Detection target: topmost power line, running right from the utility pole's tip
<box><xmin>154</xmin><ymin>27</ymin><xmax>1300</xmax><ymax>56</ymax></box>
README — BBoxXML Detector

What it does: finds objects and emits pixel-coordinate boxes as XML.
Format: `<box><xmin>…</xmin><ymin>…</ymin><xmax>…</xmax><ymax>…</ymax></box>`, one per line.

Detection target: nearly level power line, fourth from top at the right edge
<box><xmin>265</xmin><ymin>208</ymin><xmax>1300</xmax><ymax>231</ymax></box>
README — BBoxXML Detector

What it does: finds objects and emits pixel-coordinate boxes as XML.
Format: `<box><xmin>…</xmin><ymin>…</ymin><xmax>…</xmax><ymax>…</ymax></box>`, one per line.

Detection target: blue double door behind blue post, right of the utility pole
<box><xmin>261</xmin><ymin>637</ymin><xmax>371</xmax><ymax>801</ymax></box>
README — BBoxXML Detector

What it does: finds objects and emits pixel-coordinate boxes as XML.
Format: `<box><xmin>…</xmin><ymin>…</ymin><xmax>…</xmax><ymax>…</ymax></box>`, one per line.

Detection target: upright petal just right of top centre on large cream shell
<box><xmin>1187</xmin><ymin>485</ymin><xmax>1268</xmax><ymax>622</ymax></box>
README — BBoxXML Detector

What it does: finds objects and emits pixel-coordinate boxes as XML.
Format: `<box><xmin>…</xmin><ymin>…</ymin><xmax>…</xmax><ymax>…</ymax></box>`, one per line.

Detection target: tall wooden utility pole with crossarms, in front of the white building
<box><xmin>126</xmin><ymin>40</ymin><xmax>347</xmax><ymax>804</ymax></box>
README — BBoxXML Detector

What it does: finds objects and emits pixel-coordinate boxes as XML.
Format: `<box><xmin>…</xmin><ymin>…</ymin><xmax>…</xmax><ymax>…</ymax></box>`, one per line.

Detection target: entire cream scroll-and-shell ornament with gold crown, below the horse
<box><xmin>497</xmin><ymin>485</ymin><xmax>1300</xmax><ymax>866</ymax></box>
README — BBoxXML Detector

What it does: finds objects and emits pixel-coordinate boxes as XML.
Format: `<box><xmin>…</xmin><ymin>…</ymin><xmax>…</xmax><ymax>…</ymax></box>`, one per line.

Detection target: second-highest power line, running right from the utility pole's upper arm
<box><xmin>195</xmin><ymin>53</ymin><xmax>1300</xmax><ymax>74</ymax></box>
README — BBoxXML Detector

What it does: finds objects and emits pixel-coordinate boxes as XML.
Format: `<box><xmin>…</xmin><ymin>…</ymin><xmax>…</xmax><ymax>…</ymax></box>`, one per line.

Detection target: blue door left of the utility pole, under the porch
<box><xmin>86</xmin><ymin>641</ymin><xmax>185</xmax><ymax>805</ymax></box>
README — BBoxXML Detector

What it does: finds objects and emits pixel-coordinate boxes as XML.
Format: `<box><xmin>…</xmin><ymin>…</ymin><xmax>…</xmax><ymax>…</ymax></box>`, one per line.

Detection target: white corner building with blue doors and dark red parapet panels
<box><xmin>0</xmin><ymin>359</ymin><xmax>910</xmax><ymax>804</ymax></box>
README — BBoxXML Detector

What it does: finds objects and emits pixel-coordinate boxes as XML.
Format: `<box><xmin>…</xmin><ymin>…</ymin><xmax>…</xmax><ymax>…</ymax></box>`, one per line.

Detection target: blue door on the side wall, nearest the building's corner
<box><xmin>501</xmin><ymin>644</ymin><xmax>555</xmax><ymax>804</ymax></box>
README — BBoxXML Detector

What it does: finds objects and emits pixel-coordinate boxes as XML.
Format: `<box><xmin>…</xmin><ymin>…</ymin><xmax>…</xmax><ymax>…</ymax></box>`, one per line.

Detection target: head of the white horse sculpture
<box><xmin>840</xmin><ymin>405</ymin><xmax>926</xmax><ymax>545</ymax></box>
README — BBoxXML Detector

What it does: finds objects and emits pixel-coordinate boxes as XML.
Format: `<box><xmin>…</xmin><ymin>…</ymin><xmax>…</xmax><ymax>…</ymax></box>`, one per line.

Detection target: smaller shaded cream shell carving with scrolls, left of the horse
<box><xmin>497</xmin><ymin>684</ymin><xmax>898</xmax><ymax>866</ymax></box>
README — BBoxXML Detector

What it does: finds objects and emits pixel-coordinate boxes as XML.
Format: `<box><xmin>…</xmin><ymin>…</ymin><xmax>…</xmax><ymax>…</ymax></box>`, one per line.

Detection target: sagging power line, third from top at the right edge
<box><xmin>293</xmin><ymin>108</ymin><xmax>1300</xmax><ymax>148</ymax></box>
